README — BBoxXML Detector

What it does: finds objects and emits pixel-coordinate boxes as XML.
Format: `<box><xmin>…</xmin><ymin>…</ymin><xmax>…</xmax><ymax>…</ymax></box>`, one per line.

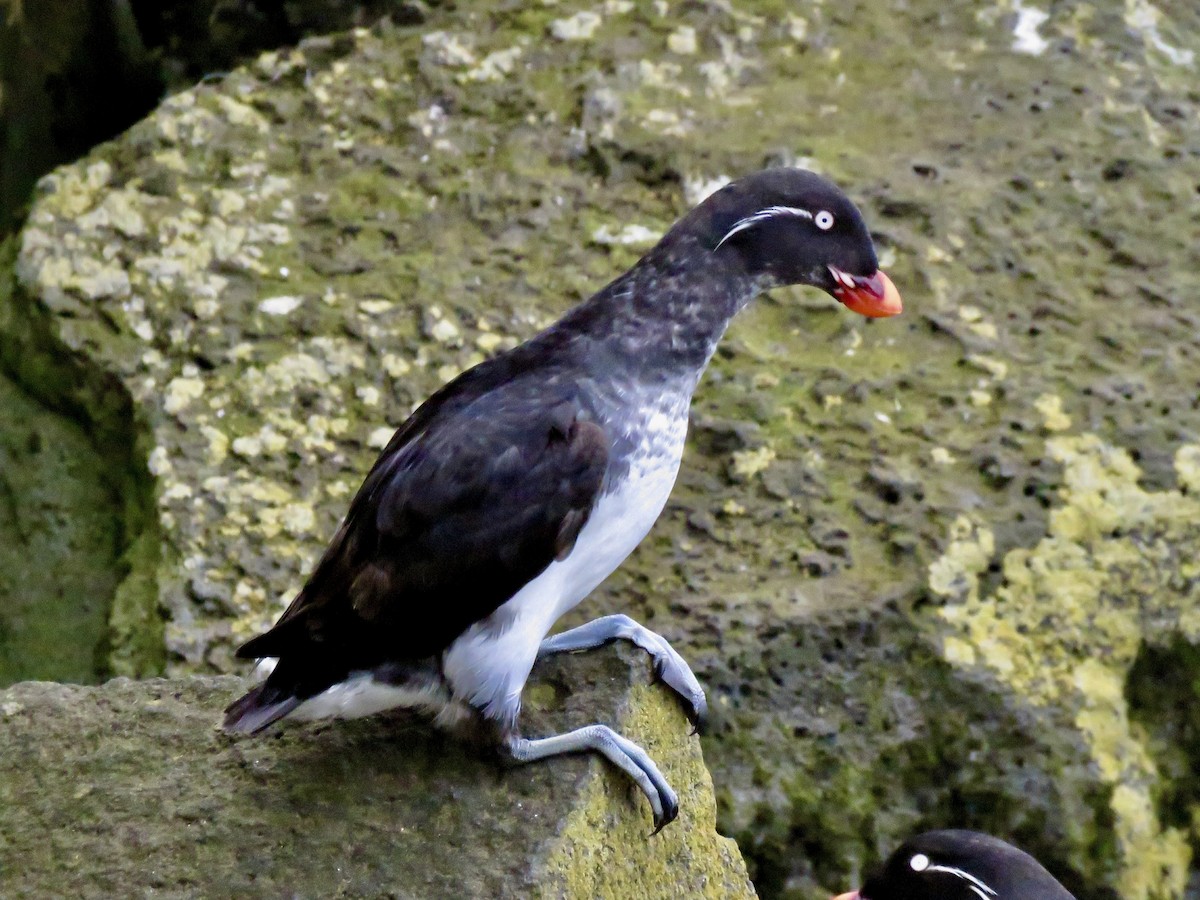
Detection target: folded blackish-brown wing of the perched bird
<box><xmin>238</xmin><ymin>378</ymin><xmax>608</xmax><ymax>696</ymax></box>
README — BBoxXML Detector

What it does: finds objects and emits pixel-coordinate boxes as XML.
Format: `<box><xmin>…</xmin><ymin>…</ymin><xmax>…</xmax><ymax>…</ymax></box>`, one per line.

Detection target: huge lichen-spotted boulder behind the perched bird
<box><xmin>0</xmin><ymin>0</ymin><xmax>1200</xmax><ymax>900</ymax></box>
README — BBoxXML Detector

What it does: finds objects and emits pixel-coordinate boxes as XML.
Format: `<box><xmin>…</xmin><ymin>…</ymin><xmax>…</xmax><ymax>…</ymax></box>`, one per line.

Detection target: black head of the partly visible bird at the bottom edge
<box><xmin>833</xmin><ymin>829</ymin><xmax>1075</xmax><ymax>900</ymax></box>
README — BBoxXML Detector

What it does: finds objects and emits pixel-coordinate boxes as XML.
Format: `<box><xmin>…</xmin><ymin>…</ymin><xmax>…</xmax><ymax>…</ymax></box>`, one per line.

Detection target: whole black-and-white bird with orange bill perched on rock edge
<box><xmin>223</xmin><ymin>167</ymin><xmax>902</xmax><ymax>832</ymax></box>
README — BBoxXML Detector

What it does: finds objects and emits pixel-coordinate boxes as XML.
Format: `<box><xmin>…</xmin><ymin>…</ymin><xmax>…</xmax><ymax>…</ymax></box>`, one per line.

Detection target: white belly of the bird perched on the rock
<box><xmin>443</xmin><ymin>427</ymin><xmax>686</xmax><ymax>724</ymax></box>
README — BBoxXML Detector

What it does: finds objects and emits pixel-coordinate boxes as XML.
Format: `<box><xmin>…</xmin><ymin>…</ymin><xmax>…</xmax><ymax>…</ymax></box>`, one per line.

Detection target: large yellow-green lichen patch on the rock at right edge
<box><xmin>930</xmin><ymin>434</ymin><xmax>1200</xmax><ymax>900</ymax></box>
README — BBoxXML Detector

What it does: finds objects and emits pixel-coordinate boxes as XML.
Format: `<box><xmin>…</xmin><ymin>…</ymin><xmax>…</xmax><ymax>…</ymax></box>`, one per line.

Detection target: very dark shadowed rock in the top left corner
<box><xmin>0</xmin><ymin>0</ymin><xmax>427</xmax><ymax>238</ymax></box>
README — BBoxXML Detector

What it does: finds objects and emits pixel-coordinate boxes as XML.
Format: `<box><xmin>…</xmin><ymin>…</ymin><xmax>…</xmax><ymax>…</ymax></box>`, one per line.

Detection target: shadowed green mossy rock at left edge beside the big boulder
<box><xmin>0</xmin><ymin>230</ymin><xmax>163</xmax><ymax>682</ymax></box>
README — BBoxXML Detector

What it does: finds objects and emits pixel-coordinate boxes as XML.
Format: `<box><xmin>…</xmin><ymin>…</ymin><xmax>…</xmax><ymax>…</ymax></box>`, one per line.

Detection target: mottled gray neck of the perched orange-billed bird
<box><xmin>554</xmin><ymin>234</ymin><xmax>760</xmax><ymax>382</ymax></box>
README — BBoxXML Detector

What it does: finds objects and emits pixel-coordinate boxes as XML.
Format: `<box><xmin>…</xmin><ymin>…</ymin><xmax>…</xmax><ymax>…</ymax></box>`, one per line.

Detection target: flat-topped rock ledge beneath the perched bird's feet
<box><xmin>0</xmin><ymin>649</ymin><xmax>754</xmax><ymax>900</ymax></box>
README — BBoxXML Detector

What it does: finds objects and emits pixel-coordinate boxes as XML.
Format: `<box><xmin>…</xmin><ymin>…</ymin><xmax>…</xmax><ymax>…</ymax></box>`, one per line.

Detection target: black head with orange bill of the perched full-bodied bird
<box><xmin>689</xmin><ymin>168</ymin><xmax>904</xmax><ymax>318</ymax></box>
